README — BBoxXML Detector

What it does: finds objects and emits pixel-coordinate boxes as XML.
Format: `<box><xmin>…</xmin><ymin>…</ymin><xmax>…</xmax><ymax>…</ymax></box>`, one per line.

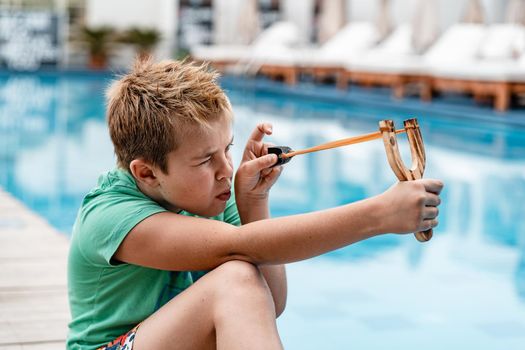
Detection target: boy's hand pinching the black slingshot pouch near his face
<box><xmin>235</xmin><ymin>123</ymin><xmax>282</xmax><ymax>200</ymax></box>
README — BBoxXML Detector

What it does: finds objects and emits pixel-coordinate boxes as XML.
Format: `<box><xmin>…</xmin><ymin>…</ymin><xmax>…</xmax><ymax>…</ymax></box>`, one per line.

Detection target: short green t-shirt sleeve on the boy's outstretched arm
<box><xmin>78</xmin><ymin>193</ymin><xmax>166</xmax><ymax>266</ymax></box>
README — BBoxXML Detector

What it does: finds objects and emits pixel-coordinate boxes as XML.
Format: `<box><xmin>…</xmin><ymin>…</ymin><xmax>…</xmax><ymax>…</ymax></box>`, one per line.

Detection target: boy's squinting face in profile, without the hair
<box><xmin>157</xmin><ymin>117</ymin><xmax>233</xmax><ymax>217</ymax></box>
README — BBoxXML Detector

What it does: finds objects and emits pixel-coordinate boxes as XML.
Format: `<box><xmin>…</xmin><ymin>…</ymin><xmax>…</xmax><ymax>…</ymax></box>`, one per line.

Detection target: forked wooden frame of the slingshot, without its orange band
<box><xmin>379</xmin><ymin>119</ymin><xmax>432</xmax><ymax>242</ymax></box>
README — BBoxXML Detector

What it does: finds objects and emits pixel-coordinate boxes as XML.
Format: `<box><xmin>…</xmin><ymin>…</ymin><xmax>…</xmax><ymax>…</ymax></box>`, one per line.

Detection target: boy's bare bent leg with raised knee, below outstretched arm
<box><xmin>133</xmin><ymin>261</ymin><xmax>282</xmax><ymax>350</ymax></box>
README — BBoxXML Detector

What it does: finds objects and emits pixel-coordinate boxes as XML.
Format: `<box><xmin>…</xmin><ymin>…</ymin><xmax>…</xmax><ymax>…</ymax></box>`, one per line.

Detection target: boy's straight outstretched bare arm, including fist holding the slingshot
<box><xmin>115</xmin><ymin>179</ymin><xmax>443</xmax><ymax>271</ymax></box>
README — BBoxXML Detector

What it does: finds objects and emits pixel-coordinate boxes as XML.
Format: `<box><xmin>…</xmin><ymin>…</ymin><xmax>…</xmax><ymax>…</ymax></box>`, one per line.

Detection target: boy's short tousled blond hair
<box><xmin>106</xmin><ymin>59</ymin><xmax>231</xmax><ymax>173</ymax></box>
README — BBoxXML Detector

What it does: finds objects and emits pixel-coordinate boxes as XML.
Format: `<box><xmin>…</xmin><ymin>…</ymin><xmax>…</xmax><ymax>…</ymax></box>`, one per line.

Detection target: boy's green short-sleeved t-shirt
<box><xmin>67</xmin><ymin>169</ymin><xmax>240</xmax><ymax>349</ymax></box>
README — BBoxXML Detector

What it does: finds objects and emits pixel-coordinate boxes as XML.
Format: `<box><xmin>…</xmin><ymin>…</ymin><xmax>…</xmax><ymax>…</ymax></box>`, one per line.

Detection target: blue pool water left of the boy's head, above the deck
<box><xmin>0</xmin><ymin>74</ymin><xmax>114</xmax><ymax>232</ymax></box>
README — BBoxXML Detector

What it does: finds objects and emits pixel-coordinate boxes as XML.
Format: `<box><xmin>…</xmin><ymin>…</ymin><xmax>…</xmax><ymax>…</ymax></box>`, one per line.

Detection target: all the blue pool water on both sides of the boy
<box><xmin>0</xmin><ymin>74</ymin><xmax>525</xmax><ymax>350</ymax></box>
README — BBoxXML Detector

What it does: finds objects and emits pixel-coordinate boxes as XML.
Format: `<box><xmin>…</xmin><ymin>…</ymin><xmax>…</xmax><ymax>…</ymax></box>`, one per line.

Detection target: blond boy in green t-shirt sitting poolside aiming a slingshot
<box><xmin>68</xmin><ymin>61</ymin><xmax>443</xmax><ymax>350</ymax></box>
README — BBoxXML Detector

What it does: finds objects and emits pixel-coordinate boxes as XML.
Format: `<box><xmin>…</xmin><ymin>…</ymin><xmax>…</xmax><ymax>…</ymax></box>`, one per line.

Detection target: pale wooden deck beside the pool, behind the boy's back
<box><xmin>0</xmin><ymin>190</ymin><xmax>70</xmax><ymax>350</ymax></box>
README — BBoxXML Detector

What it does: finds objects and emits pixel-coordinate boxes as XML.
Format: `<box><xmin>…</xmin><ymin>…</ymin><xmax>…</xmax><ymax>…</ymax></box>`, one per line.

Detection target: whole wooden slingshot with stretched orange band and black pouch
<box><xmin>268</xmin><ymin>119</ymin><xmax>432</xmax><ymax>242</ymax></box>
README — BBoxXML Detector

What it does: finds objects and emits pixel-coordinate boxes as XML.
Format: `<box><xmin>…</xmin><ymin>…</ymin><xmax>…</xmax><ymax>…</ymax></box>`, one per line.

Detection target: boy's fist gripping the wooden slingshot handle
<box><xmin>379</xmin><ymin>179</ymin><xmax>443</xmax><ymax>233</ymax></box>
